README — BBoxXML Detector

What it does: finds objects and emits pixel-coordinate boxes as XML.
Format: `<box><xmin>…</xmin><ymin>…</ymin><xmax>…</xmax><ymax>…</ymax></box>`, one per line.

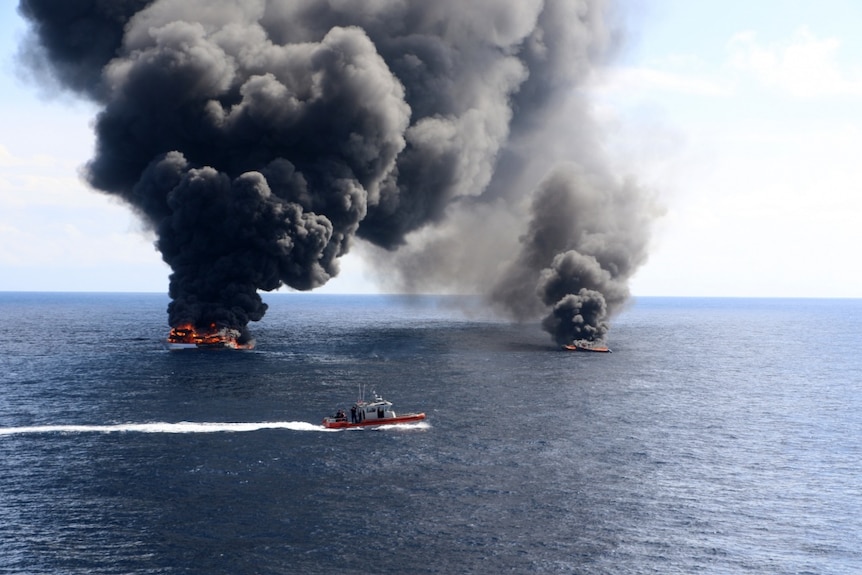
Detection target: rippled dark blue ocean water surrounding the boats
<box><xmin>0</xmin><ymin>293</ymin><xmax>862</xmax><ymax>574</ymax></box>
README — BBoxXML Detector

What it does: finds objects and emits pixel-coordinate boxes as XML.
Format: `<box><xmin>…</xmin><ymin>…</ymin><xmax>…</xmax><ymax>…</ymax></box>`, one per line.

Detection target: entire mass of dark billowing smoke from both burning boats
<box><xmin>19</xmin><ymin>0</ymin><xmax>651</xmax><ymax>342</ymax></box>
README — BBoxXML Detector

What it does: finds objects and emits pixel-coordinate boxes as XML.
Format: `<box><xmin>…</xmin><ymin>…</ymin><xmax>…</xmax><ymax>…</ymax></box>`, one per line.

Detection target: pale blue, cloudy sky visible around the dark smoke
<box><xmin>0</xmin><ymin>0</ymin><xmax>862</xmax><ymax>298</ymax></box>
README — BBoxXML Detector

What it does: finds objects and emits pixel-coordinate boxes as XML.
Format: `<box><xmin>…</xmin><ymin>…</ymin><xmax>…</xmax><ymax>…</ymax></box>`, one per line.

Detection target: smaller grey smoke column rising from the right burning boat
<box><xmin>491</xmin><ymin>164</ymin><xmax>657</xmax><ymax>345</ymax></box>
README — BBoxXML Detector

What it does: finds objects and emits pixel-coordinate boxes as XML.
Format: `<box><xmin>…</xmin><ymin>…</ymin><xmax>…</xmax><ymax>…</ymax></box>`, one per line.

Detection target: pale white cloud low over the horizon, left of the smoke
<box><xmin>0</xmin><ymin>141</ymin><xmax>166</xmax><ymax>289</ymax></box>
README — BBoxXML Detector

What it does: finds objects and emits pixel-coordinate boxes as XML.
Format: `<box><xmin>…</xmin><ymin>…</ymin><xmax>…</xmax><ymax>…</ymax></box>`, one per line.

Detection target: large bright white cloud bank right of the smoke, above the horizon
<box><xmin>594</xmin><ymin>22</ymin><xmax>862</xmax><ymax>297</ymax></box>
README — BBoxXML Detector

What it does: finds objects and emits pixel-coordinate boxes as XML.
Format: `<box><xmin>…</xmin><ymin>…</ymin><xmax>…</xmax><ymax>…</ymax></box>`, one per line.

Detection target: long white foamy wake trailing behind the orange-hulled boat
<box><xmin>0</xmin><ymin>421</ymin><xmax>337</xmax><ymax>435</ymax></box>
